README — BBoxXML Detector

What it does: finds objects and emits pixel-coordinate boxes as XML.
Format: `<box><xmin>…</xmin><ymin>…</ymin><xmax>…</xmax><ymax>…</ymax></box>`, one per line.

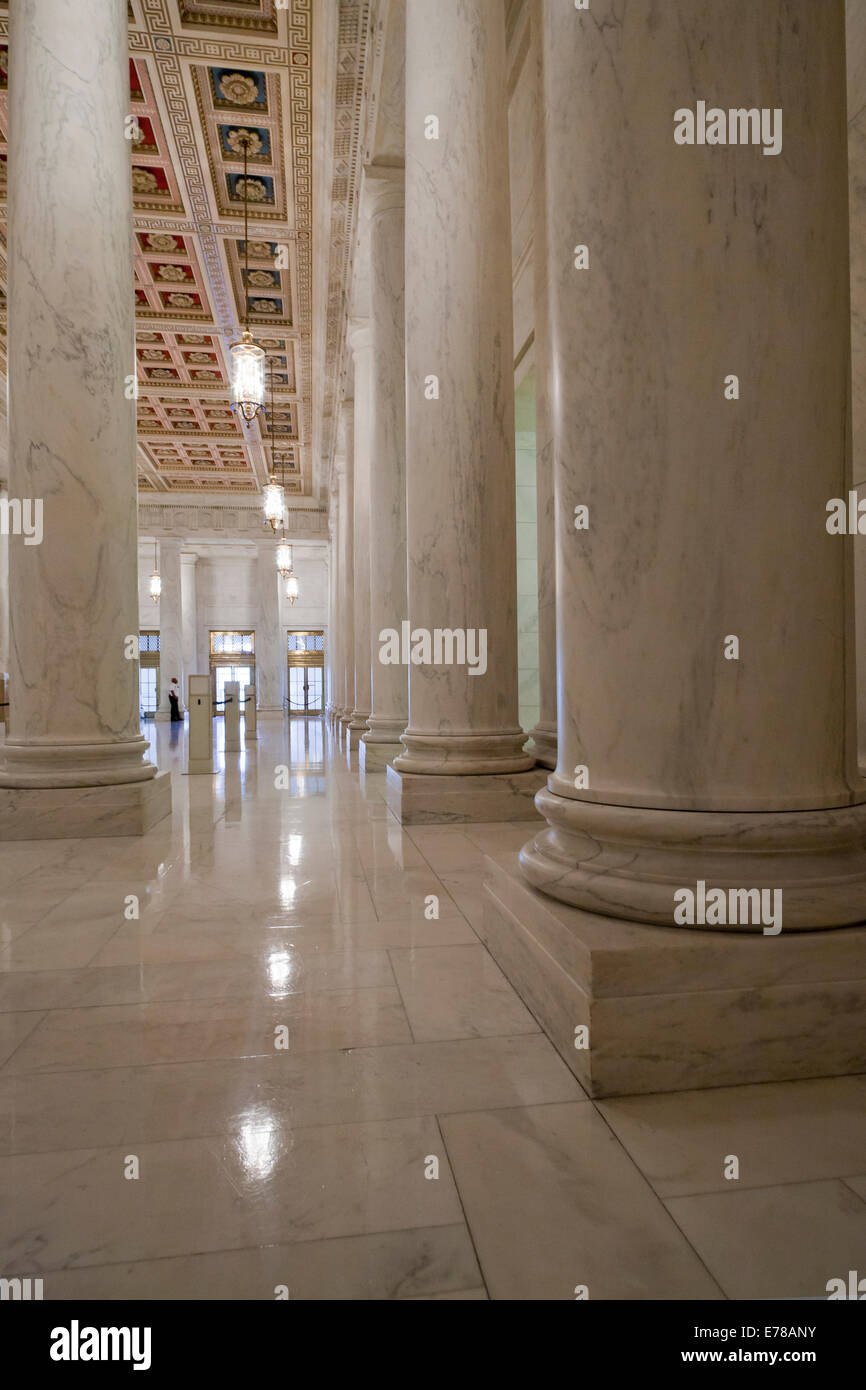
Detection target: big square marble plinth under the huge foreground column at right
<box><xmin>478</xmin><ymin>855</ymin><xmax>866</xmax><ymax>1097</ymax></box>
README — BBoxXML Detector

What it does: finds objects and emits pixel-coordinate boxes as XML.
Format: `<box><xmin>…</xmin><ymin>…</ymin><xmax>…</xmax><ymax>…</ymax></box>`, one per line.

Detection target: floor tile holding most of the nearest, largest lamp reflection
<box><xmin>0</xmin><ymin>1118</ymin><xmax>463</xmax><ymax>1275</ymax></box>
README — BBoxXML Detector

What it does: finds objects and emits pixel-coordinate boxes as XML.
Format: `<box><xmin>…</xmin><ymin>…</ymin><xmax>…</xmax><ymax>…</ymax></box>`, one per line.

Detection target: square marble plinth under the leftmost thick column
<box><xmin>0</xmin><ymin>771</ymin><xmax>171</xmax><ymax>844</ymax></box>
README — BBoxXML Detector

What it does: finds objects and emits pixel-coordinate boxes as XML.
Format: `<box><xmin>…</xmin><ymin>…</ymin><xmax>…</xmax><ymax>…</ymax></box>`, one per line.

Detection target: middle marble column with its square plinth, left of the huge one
<box><xmin>388</xmin><ymin>0</ymin><xmax>538</xmax><ymax>820</ymax></box>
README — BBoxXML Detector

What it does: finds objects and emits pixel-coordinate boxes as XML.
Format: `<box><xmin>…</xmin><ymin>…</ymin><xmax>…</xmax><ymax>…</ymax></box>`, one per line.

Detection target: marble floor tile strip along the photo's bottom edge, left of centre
<box><xmin>33</xmin><ymin>1223</ymin><xmax>487</xmax><ymax>1302</ymax></box>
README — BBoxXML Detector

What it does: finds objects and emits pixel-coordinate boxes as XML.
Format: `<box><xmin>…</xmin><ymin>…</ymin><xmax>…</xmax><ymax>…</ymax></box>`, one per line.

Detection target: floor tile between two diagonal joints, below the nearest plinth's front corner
<box><xmin>441</xmin><ymin>1102</ymin><xmax>721</xmax><ymax>1300</ymax></box>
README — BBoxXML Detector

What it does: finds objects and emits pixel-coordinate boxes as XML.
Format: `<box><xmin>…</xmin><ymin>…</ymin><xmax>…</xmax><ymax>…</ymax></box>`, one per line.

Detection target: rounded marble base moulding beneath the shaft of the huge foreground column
<box><xmin>520</xmin><ymin>788</ymin><xmax>866</xmax><ymax>933</ymax></box>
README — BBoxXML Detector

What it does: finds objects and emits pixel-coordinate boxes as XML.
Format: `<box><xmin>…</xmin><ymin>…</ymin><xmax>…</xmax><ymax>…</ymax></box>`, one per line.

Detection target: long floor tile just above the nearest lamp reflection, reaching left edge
<box><xmin>0</xmin><ymin>1033</ymin><xmax>582</xmax><ymax>1154</ymax></box>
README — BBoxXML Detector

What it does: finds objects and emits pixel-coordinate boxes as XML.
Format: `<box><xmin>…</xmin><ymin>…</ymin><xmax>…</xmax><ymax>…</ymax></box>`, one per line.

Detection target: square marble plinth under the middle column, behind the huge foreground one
<box><xmin>385</xmin><ymin>766</ymin><xmax>548</xmax><ymax>826</ymax></box>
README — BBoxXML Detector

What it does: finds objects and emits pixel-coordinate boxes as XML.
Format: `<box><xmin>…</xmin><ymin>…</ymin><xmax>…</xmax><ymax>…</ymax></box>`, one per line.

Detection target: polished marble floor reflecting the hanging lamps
<box><xmin>0</xmin><ymin>720</ymin><xmax>866</xmax><ymax>1300</ymax></box>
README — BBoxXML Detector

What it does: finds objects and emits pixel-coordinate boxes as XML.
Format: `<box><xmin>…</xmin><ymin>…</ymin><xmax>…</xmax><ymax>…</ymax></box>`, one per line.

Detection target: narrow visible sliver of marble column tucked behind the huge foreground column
<box><xmin>531</xmin><ymin>0</ymin><xmax>556</xmax><ymax>769</ymax></box>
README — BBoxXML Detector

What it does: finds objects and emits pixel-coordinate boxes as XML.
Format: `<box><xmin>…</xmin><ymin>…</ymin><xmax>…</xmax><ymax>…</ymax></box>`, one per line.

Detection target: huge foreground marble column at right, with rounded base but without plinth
<box><xmin>521</xmin><ymin>0</ymin><xmax>866</xmax><ymax>931</ymax></box>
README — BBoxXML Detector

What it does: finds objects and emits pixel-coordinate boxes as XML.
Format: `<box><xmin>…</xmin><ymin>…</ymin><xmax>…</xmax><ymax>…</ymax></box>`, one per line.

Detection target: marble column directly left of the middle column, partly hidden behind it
<box><xmin>361</xmin><ymin>168</ymin><xmax>409</xmax><ymax>771</ymax></box>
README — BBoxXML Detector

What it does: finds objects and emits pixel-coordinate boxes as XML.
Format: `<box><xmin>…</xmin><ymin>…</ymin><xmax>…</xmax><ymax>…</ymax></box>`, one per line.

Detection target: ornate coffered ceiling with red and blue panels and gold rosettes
<box><xmin>0</xmin><ymin>0</ymin><xmax>327</xmax><ymax>500</ymax></box>
